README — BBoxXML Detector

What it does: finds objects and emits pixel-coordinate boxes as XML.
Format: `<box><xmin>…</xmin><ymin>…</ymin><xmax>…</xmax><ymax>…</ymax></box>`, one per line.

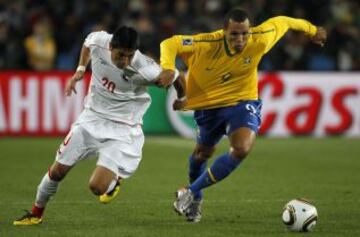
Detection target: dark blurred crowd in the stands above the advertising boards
<box><xmin>0</xmin><ymin>0</ymin><xmax>360</xmax><ymax>71</ymax></box>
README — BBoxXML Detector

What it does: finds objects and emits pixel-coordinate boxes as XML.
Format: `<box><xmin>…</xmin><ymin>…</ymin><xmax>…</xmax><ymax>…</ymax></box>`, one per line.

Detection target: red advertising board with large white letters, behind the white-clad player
<box><xmin>0</xmin><ymin>71</ymin><xmax>89</xmax><ymax>136</ymax></box>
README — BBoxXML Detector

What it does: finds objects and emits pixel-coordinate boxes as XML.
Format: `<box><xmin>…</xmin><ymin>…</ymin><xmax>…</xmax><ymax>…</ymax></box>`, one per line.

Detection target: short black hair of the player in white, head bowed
<box><xmin>110</xmin><ymin>26</ymin><xmax>139</xmax><ymax>50</ymax></box>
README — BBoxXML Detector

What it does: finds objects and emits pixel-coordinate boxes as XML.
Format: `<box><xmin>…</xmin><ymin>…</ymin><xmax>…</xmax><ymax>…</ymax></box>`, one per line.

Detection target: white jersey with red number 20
<box><xmin>84</xmin><ymin>31</ymin><xmax>162</xmax><ymax>125</ymax></box>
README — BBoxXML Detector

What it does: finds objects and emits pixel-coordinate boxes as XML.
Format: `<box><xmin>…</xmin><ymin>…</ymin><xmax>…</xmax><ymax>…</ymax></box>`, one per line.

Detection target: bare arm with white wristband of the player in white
<box><xmin>65</xmin><ymin>46</ymin><xmax>90</xmax><ymax>96</ymax></box>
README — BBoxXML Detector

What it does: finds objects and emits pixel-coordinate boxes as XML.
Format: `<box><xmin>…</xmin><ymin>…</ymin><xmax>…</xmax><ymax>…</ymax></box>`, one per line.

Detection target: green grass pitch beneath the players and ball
<box><xmin>0</xmin><ymin>137</ymin><xmax>360</xmax><ymax>237</ymax></box>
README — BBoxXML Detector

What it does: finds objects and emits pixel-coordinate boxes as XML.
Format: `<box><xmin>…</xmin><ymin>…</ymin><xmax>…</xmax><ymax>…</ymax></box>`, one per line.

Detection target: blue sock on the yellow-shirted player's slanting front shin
<box><xmin>189</xmin><ymin>153</ymin><xmax>241</xmax><ymax>194</ymax></box>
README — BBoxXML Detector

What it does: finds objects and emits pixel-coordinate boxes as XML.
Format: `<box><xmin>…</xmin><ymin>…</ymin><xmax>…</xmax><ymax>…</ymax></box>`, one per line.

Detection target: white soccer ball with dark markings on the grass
<box><xmin>282</xmin><ymin>198</ymin><xmax>318</xmax><ymax>232</ymax></box>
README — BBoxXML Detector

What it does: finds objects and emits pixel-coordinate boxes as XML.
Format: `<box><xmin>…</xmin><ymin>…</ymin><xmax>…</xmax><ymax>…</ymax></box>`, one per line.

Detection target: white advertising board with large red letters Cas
<box><xmin>259</xmin><ymin>72</ymin><xmax>360</xmax><ymax>137</ymax></box>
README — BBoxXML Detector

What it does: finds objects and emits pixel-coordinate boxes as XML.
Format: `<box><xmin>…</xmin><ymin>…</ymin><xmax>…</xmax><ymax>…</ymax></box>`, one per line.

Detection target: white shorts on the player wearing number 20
<box><xmin>56</xmin><ymin>110</ymin><xmax>144</xmax><ymax>178</ymax></box>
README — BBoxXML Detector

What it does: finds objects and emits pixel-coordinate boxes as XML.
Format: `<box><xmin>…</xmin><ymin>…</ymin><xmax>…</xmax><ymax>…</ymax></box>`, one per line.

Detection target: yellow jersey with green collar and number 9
<box><xmin>160</xmin><ymin>16</ymin><xmax>316</xmax><ymax>110</ymax></box>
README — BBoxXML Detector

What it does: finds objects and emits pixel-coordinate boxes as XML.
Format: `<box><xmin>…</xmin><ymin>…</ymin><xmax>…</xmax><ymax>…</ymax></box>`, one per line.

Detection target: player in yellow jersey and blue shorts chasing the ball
<box><xmin>160</xmin><ymin>8</ymin><xmax>326</xmax><ymax>222</ymax></box>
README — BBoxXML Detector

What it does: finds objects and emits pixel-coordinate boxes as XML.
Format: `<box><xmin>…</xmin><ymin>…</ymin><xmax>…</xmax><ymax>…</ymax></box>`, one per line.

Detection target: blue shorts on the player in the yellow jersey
<box><xmin>194</xmin><ymin>99</ymin><xmax>262</xmax><ymax>146</ymax></box>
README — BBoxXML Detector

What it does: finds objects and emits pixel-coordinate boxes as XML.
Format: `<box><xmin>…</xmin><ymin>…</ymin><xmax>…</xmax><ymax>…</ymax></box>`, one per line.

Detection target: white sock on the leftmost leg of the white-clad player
<box><xmin>35</xmin><ymin>173</ymin><xmax>60</xmax><ymax>208</ymax></box>
